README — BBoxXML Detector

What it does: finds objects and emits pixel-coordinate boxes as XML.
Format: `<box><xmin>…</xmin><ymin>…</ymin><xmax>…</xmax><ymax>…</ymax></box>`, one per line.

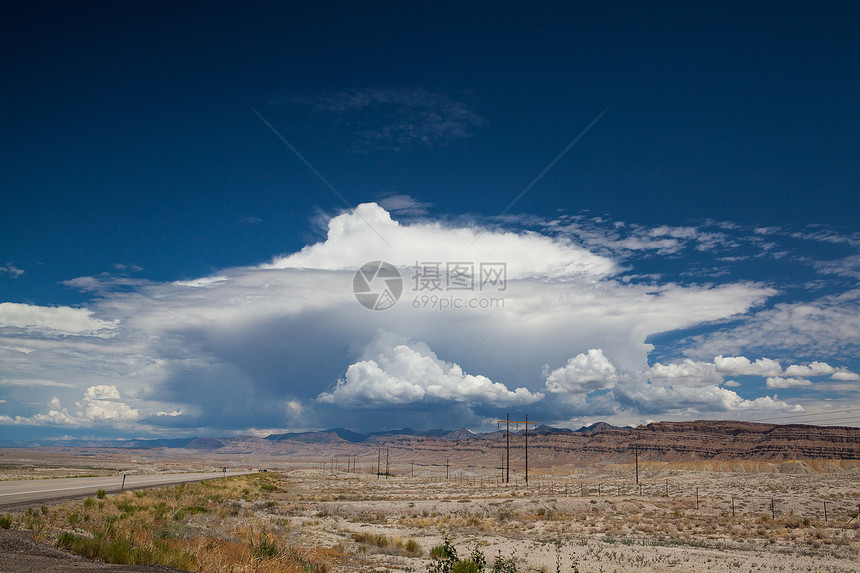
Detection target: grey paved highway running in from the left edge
<box><xmin>0</xmin><ymin>471</ymin><xmax>254</xmax><ymax>507</ymax></box>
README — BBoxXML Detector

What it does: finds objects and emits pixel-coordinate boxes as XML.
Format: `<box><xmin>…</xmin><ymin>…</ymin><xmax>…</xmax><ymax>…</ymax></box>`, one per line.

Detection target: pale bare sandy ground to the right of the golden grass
<box><xmin>0</xmin><ymin>457</ymin><xmax>860</xmax><ymax>573</ymax></box>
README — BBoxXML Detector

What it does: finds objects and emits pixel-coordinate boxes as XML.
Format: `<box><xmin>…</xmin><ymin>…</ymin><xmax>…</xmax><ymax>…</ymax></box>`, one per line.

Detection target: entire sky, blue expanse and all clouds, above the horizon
<box><xmin>0</xmin><ymin>2</ymin><xmax>860</xmax><ymax>439</ymax></box>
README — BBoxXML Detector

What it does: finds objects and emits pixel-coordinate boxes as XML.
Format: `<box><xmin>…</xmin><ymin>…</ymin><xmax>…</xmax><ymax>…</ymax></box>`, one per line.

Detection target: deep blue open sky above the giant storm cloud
<box><xmin>0</xmin><ymin>2</ymin><xmax>860</xmax><ymax>436</ymax></box>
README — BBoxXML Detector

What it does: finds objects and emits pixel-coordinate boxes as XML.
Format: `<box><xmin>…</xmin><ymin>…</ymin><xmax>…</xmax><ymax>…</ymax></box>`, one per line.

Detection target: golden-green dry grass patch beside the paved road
<box><xmin>15</xmin><ymin>474</ymin><xmax>342</xmax><ymax>573</ymax></box>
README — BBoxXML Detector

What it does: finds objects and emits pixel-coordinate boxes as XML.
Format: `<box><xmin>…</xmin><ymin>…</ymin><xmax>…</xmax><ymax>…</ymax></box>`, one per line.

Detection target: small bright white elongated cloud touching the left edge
<box><xmin>0</xmin><ymin>302</ymin><xmax>116</xmax><ymax>334</ymax></box>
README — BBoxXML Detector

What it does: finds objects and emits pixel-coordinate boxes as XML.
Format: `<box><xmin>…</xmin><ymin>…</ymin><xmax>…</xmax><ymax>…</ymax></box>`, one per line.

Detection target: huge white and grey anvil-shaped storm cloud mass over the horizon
<box><xmin>0</xmin><ymin>203</ymin><xmax>858</xmax><ymax>432</ymax></box>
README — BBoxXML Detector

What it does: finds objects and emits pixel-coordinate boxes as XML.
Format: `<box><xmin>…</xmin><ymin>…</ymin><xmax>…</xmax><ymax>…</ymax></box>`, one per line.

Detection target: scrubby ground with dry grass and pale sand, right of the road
<box><xmin>0</xmin><ymin>460</ymin><xmax>860</xmax><ymax>573</ymax></box>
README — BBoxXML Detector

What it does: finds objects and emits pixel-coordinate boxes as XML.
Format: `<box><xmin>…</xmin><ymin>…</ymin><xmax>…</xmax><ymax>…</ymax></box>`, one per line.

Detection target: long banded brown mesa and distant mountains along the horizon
<box><xmin>6</xmin><ymin>420</ymin><xmax>860</xmax><ymax>467</ymax></box>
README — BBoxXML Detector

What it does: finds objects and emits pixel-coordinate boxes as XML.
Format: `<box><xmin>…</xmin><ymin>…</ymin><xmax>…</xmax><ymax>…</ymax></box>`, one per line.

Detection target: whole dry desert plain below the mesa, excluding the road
<box><xmin>0</xmin><ymin>447</ymin><xmax>860</xmax><ymax>573</ymax></box>
